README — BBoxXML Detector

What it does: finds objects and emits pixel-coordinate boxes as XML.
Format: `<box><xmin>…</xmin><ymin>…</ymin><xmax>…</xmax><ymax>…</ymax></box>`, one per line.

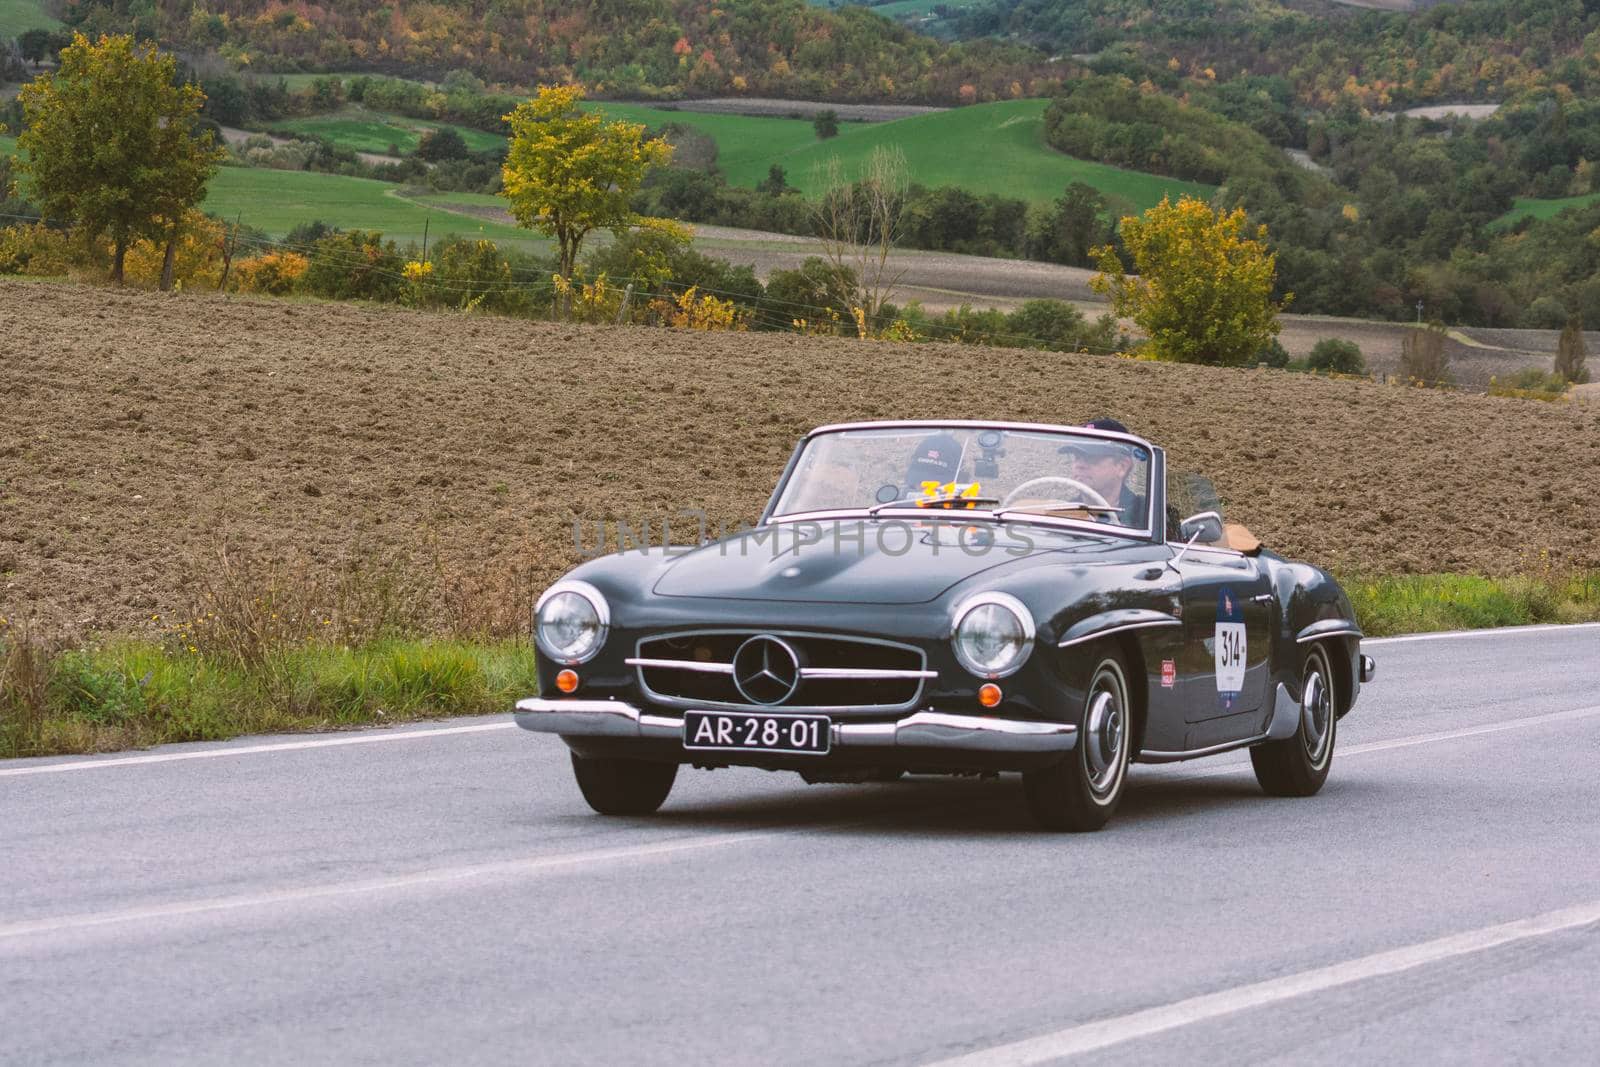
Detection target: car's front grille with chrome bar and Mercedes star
<box><xmin>627</xmin><ymin>630</ymin><xmax>934</xmax><ymax>712</ymax></box>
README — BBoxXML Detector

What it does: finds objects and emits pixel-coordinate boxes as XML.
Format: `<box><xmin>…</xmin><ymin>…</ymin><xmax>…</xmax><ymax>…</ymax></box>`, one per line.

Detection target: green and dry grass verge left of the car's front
<box><xmin>0</xmin><ymin>638</ymin><xmax>538</xmax><ymax>757</ymax></box>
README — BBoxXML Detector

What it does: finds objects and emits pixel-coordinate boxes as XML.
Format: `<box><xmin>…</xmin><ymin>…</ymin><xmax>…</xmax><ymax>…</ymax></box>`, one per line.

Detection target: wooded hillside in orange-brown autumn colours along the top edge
<box><xmin>69</xmin><ymin>0</ymin><xmax>1048</xmax><ymax>102</ymax></box>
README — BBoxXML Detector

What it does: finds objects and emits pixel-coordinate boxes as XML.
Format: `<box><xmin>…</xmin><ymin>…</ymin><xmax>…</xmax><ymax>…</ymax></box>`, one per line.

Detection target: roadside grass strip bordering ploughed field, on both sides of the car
<box><xmin>0</xmin><ymin>573</ymin><xmax>1600</xmax><ymax>758</ymax></box>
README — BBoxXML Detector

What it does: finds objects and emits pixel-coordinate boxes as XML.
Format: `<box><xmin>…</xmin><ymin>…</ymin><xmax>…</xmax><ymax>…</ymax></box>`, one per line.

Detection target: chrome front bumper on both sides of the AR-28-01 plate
<box><xmin>515</xmin><ymin>697</ymin><xmax>1078</xmax><ymax>752</ymax></box>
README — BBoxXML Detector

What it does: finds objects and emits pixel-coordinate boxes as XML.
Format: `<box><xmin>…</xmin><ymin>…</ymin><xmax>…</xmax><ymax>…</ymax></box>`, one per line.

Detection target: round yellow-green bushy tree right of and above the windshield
<box><xmin>1090</xmin><ymin>197</ymin><xmax>1290</xmax><ymax>366</ymax></box>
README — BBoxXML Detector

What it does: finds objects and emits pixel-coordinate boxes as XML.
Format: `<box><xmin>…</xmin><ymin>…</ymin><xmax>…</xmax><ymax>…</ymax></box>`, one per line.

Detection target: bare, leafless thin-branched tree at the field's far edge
<box><xmin>811</xmin><ymin>147</ymin><xmax>906</xmax><ymax>331</ymax></box>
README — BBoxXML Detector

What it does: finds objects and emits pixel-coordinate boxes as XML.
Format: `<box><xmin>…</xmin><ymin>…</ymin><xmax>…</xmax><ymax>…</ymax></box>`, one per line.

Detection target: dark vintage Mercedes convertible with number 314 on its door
<box><xmin>515</xmin><ymin>421</ymin><xmax>1374</xmax><ymax>830</ymax></box>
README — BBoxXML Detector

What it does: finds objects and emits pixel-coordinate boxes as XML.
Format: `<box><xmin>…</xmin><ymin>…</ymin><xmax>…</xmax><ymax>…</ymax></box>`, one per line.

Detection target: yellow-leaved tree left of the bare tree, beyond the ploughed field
<box><xmin>501</xmin><ymin>85</ymin><xmax>672</xmax><ymax>310</ymax></box>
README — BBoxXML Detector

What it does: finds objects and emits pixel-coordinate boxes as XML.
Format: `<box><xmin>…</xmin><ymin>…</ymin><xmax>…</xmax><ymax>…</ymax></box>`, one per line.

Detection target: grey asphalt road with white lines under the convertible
<box><xmin>0</xmin><ymin>627</ymin><xmax>1600</xmax><ymax>1067</ymax></box>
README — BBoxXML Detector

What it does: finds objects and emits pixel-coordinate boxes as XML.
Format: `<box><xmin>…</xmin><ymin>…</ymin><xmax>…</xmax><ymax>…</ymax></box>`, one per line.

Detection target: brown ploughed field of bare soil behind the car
<box><xmin>0</xmin><ymin>282</ymin><xmax>1600</xmax><ymax>630</ymax></box>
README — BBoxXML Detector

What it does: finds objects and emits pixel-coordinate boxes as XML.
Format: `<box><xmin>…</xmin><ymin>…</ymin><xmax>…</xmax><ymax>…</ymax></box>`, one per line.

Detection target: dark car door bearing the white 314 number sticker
<box><xmin>1174</xmin><ymin>544</ymin><xmax>1272</xmax><ymax>733</ymax></box>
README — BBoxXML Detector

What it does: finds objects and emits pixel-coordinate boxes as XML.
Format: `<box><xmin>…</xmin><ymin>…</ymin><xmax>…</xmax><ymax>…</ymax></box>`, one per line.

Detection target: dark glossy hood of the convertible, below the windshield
<box><xmin>654</xmin><ymin>522</ymin><xmax>1126</xmax><ymax>605</ymax></box>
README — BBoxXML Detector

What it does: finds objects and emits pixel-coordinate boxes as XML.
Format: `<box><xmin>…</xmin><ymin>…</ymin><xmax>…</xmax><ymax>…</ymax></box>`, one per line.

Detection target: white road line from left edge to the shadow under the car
<box><xmin>0</xmin><ymin>832</ymin><xmax>778</xmax><ymax>941</ymax></box>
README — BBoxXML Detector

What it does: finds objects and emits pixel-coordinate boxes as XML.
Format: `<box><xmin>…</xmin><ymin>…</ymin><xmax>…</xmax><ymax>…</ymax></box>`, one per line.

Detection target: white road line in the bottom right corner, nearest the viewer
<box><xmin>931</xmin><ymin>901</ymin><xmax>1600</xmax><ymax>1067</ymax></box>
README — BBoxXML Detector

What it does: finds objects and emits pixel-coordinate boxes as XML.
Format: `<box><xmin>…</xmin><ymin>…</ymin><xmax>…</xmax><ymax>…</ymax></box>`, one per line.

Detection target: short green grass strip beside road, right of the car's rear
<box><xmin>1339</xmin><ymin>573</ymin><xmax>1600</xmax><ymax>637</ymax></box>
